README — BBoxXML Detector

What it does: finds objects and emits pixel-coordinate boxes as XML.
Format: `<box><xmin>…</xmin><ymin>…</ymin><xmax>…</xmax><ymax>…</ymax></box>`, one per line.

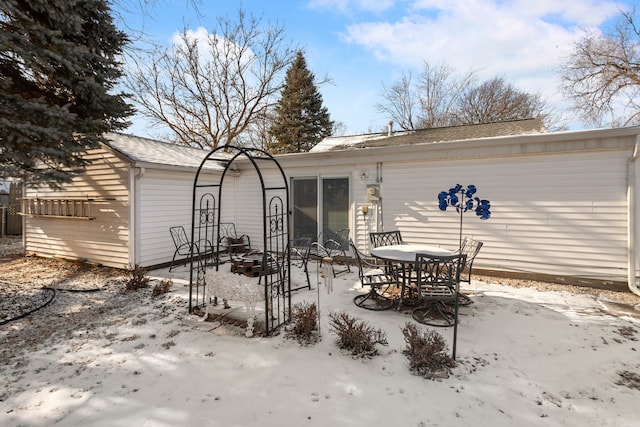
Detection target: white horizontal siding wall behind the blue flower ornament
<box><xmin>382</xmin><ymin>151</ymin><xmax>629</xmax><ymax>280</ymax></box>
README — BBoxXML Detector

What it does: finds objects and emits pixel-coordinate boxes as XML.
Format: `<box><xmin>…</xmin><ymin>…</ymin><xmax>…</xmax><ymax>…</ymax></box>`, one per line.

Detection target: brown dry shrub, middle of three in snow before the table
<box><xmin>329</xmin><ymin>312</ymin><xmax>387</xmax><ymax>357</ymax></box>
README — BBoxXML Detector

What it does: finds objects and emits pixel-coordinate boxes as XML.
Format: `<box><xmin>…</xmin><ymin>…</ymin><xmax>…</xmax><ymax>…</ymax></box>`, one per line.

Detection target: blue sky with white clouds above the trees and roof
<box><xmin>117</xmin><ymin>0</ymin><xmax>640</xmax><ymax>137</ymax></box>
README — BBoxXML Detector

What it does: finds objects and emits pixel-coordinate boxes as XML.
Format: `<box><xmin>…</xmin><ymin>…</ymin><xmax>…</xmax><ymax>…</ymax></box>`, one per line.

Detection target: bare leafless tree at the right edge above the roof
<box><xmin>560</xmin><ymin>9</ymin><xmax>640</xmax><ymax>126</ymax></box>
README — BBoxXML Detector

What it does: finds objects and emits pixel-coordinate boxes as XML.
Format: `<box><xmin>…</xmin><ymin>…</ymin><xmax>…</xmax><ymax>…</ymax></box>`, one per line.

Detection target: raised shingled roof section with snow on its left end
<box><xmin>310</xmin><ymin>118</ymin><xmax>546</xmax><ymax>152</ymax></box>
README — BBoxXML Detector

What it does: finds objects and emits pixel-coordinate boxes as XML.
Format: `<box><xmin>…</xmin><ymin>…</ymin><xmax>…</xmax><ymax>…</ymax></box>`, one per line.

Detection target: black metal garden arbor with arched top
<box><xmin>189</xmin><ymin>146</ymin><xmax>291</xmax><ymax>334</ymax></box>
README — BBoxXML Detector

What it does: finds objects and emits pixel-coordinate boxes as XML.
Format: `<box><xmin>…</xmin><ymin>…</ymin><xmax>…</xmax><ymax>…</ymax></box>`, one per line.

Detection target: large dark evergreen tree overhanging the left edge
<box><xmin>0</xmin><ymin>0</ymin><xmax>132</xmax><ymax>187</ymax></box>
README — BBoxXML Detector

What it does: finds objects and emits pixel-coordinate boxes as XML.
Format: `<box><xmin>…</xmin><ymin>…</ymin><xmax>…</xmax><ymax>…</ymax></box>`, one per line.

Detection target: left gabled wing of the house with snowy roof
<box><xmin>22</xmin><ymin>134</ymin><xmax>222</xmax><ymax>268</ymax></box>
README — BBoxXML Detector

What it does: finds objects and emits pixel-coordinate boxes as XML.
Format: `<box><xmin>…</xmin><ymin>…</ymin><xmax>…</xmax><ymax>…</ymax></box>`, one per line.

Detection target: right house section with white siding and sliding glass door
<box><xmin>239</xmin><ymin>122</ymin><xmax>640</xmax><ymax>288</ymax></box>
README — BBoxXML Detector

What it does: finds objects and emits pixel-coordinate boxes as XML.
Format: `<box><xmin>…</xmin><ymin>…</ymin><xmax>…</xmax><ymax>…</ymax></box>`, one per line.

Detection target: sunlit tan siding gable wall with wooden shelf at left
<box><xmin>24</xmin><ymin>149</ymin><xmax>129</xmax><ymax>268</ymax></box>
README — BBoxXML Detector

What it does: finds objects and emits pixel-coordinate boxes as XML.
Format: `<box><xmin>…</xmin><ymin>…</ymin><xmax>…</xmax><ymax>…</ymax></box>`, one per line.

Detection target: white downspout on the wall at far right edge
<box><xmin>627</xmin><ymin>138</ymin><xmax>640</xmax><ymax>296</ymax></box>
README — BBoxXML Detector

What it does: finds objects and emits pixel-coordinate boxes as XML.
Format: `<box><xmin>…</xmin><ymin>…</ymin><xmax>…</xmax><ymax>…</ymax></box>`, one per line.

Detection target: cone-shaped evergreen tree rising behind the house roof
<box><xmin>270</xmin><ymin>52</ymin><xmax>333</xmax><ymax>153</ymax></box>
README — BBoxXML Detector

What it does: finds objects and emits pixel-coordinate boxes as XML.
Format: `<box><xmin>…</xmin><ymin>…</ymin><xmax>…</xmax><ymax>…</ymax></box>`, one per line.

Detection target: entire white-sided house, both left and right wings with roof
<box><xmin>25</xmin><ymin>122</ymin><xmax>640</xmax><ymax>289</ymax></box>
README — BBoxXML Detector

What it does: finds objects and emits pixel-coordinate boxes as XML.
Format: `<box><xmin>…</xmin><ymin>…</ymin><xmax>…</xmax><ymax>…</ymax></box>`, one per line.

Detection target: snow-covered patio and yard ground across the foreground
<box><xmin>0</xmin><ymin>256</ymin><xmax>640</xmax><ymax>426</ymax></box>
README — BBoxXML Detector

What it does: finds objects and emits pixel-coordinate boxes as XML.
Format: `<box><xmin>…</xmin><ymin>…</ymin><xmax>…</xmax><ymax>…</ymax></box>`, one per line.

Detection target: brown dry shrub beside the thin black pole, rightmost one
<box><xmin>402</xmin><ymin>323</ymin><xmax>456</xmax><ymax>379</ymax></box>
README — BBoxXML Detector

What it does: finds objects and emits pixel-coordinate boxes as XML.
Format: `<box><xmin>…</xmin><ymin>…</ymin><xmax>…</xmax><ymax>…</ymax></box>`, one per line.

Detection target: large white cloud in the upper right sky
<box><xmin>343</xmin><ymin>0</ymin><xmax>620</xmax><ymax>107</ymax></box>
